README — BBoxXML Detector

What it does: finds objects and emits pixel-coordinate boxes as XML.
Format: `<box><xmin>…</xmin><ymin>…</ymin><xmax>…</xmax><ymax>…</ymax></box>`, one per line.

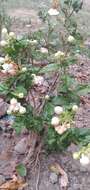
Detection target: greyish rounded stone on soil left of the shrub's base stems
<box><xmin>14</xmin><ymin>138</ymin><xmax>27</xmax><ymax>154</ymax></box>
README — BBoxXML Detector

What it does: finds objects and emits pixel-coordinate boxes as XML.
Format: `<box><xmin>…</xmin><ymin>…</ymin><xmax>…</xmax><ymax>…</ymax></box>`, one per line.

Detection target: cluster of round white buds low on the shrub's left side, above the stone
<box><xmin>7</xmin><ymin>98</ymin><xmax>26</xmax><ymax>114</ymax></box>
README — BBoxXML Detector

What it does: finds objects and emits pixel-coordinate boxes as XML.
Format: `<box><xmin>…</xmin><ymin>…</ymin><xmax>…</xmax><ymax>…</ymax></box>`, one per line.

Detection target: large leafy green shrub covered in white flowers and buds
<box><xmin>0</xmin><ymin>0</ymin><xmax>90</xmax><ymax>163</ymax></box>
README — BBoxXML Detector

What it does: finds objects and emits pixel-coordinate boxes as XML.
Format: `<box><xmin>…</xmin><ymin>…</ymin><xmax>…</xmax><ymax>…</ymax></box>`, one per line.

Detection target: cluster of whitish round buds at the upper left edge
<box><xmin>0</xmin><ymin>28</ymin><xmax>16</xmax><ymax>47</ymax></box>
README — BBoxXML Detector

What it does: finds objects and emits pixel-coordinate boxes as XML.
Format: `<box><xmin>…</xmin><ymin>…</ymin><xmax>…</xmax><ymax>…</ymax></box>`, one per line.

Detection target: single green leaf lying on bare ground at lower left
<box><xmin>16</xmin><ymin>163</ymin><xmax>27</xmax><ymax>177</ymax></box>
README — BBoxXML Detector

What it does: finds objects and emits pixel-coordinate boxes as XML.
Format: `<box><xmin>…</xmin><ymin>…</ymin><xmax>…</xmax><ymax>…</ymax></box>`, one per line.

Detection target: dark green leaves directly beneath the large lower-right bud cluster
<box><xmin>45</xmin><ymin>127</ymin><xmax>90</xmax><ymax>151</ymax></box>
